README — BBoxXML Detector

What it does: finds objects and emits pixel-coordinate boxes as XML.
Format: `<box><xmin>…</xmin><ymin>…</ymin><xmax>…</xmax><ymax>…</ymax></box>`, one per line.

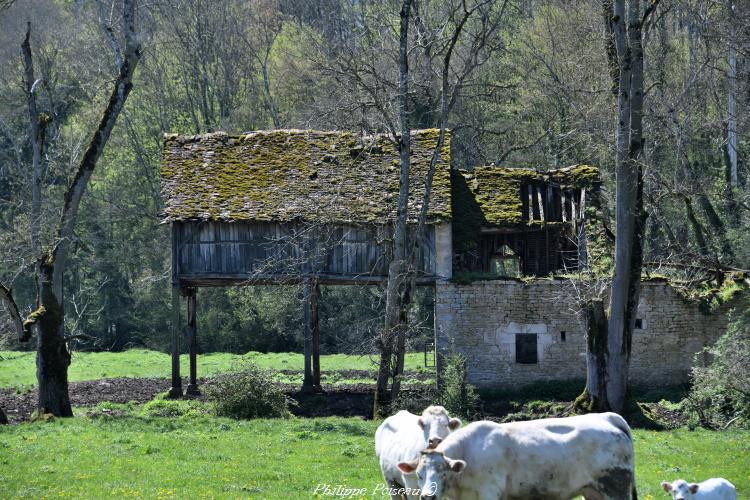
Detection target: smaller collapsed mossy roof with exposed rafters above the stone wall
<box><xmin>452</xmin><ymin>165</ymin><xmax>600</xmax><ymax>226</ymax></box>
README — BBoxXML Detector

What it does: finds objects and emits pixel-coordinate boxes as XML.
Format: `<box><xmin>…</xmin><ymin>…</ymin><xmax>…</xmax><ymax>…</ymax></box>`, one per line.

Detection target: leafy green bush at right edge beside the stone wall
<box><xmin>683</xmin><ymin>309</ymin><xmax>750</xmax><ymax>428</ymax></box>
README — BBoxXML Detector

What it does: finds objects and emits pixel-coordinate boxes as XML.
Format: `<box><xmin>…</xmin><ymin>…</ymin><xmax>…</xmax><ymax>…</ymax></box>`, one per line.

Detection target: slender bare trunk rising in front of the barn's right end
<box><xmin>373</xmin><ymin>0</ymin><xmax>411</xmax><ymax>418</ymax></box>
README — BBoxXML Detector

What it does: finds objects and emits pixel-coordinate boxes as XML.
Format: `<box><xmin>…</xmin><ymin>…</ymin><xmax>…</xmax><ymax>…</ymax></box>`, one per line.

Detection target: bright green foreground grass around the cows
<box><xmin>0</xmin><ymin>412</ymin><xmax>750</xmax><ymax>499</ymax></box>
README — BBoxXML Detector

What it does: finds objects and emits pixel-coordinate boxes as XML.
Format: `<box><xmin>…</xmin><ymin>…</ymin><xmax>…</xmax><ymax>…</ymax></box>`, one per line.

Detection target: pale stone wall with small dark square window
<box><xmin>435</xmin><ymin>280</ymin><xmax>730</xmax><ymax>387</ymax></box>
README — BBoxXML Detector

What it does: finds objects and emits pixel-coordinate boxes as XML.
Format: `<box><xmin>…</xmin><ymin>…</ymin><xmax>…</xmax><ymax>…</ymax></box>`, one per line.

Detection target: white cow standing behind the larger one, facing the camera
<box><xmin>375</xmin><ymin>406</ymin><xmax>461</xmax><ymax>499</ymax></box>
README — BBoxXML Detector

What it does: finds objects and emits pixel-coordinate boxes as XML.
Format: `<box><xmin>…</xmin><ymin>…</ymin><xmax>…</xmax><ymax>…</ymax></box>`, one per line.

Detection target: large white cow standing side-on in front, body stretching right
<box><xmin>398</xmin><ymin>413</ymin><xmax>637</xmax><ymax>500</ymax></box>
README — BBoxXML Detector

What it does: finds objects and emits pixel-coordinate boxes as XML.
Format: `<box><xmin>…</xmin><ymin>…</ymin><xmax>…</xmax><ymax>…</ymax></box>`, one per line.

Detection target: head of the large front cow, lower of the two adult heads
<box><xmin>398</xmin><ymin>449</ymin><xmax>466</xmax><ymax>500</ymax></box>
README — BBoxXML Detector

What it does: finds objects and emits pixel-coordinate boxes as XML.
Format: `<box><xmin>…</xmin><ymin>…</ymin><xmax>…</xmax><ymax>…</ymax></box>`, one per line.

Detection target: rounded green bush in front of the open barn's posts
<box><xmin>205</xmin><ymin>360</ymin><xmax>293</xmax><ymax>419</ymax></box>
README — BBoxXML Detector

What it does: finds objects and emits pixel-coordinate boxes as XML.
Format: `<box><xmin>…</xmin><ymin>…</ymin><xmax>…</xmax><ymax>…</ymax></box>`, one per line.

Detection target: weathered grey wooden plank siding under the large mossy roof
<box><xmin>173</xmin><ymin>221</ymin><xmax>435</xmax><ymax>281</ymax></box>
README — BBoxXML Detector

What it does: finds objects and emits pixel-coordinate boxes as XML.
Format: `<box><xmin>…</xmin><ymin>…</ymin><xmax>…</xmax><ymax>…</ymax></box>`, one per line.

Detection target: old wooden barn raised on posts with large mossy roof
<box><xmin>161</xmin><ymin>130</ymin><xmax>452</xmax><ymax>396</ymax></box>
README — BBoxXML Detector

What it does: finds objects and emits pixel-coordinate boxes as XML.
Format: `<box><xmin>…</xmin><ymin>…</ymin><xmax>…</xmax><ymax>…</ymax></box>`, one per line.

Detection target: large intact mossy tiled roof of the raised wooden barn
<box><xmin>161</xmin><ymin>129</ymin><xmax>451</xmax><ymax>223</ymax></box>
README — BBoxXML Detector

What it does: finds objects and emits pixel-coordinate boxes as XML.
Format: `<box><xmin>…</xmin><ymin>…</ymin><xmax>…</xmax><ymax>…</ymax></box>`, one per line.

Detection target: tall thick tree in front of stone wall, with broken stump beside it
<box><xmin>586</xmin><ymin>0</ymin><xmax>659</xmax><ymax>412</ymax></box>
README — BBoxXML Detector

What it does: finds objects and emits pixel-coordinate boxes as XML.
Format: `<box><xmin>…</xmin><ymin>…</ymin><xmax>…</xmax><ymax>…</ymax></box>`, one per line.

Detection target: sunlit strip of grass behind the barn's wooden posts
<box><xmin>0</xmin><ymin>349</ymin><xmax>425</xmax><ymax>389</ymax></box>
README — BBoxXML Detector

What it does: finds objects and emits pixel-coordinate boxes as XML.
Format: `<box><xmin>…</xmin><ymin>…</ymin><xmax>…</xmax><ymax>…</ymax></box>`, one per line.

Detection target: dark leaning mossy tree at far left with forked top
<box><xmin>0</xmin><ymin>0</ymin><xmax>141</xmax><ymax>417</ymax></box>
